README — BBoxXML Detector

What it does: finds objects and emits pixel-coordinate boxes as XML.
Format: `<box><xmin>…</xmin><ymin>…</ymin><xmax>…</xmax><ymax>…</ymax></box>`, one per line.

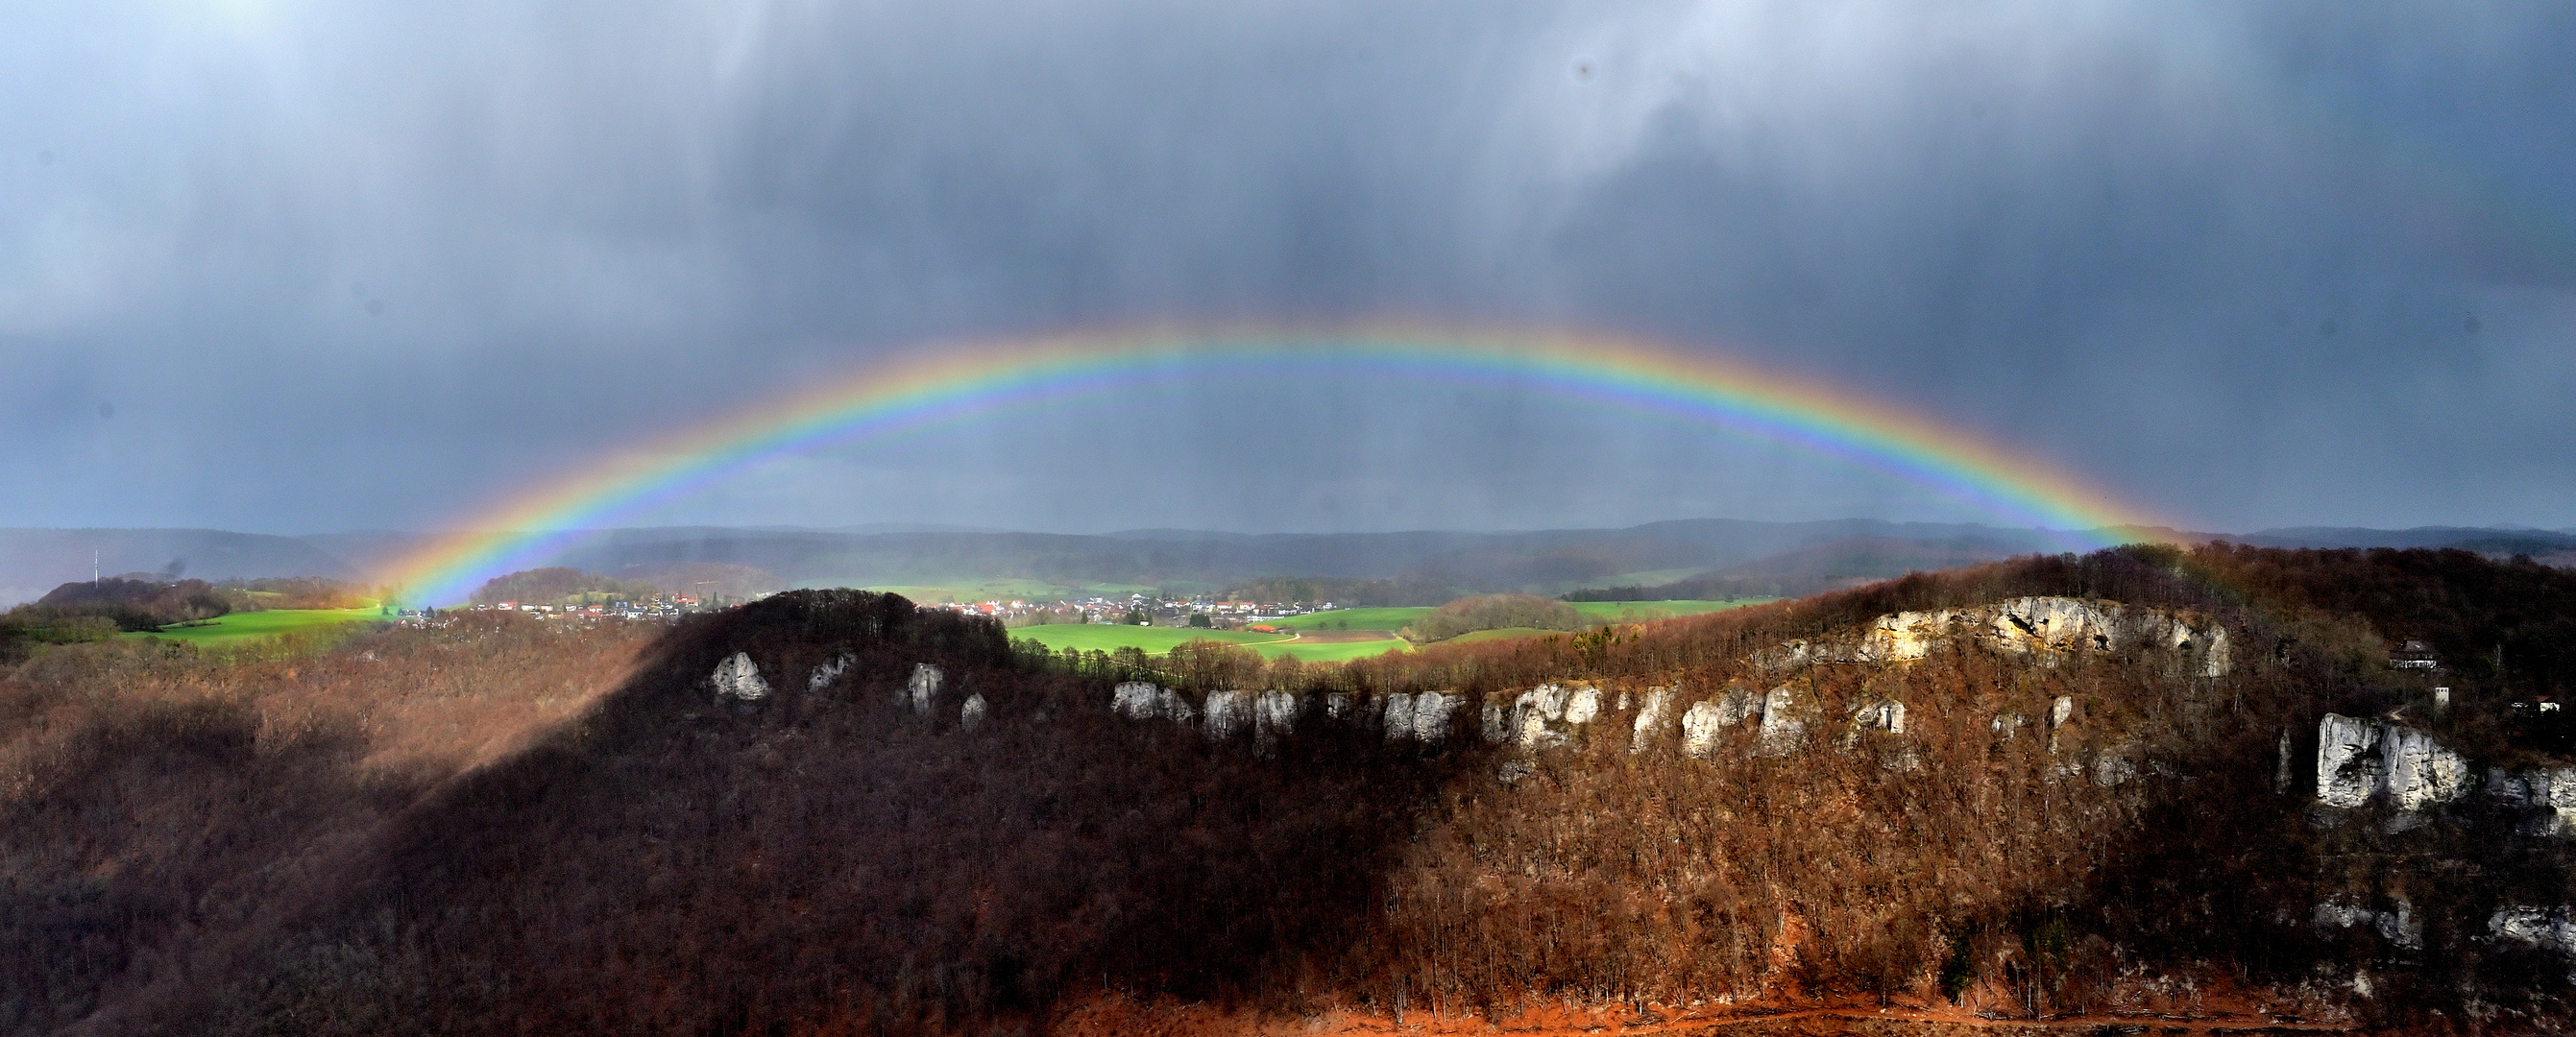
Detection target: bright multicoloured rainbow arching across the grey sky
<box><xmin>373</xmin><ymin>325</ymin><xmax>2153</xmax><ymax>605</ymax></box>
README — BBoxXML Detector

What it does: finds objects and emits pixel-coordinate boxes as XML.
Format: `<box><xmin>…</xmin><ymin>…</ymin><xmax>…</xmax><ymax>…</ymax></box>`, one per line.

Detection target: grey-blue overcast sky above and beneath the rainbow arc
<box><xmin>0</xmin><ymin>0</ymin><xmax>2576</xmax><ymax>533</ymax></box>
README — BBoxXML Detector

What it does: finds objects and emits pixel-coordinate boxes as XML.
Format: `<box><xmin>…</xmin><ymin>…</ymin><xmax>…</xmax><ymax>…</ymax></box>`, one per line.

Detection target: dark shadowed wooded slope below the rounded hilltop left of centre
<box><xmin>160</xmin><ymin>591</ymin><xmax>1469</xmax><ymax>1034</ymax></box>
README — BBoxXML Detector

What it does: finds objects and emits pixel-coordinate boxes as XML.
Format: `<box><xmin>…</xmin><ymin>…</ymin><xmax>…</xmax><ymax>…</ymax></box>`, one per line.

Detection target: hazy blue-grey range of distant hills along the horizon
<box><xmin>0</xmin><ymin>519</ymin><xmax>2576</xmax><ymax>605</ymax></box>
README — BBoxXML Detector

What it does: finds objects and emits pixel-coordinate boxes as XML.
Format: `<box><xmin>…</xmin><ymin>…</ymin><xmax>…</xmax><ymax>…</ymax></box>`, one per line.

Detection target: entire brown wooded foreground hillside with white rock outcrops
<box><xmin>0</xmin><ymin>548</ymin><xmax>2576</xmax><ymax>1034</ymax></box>
